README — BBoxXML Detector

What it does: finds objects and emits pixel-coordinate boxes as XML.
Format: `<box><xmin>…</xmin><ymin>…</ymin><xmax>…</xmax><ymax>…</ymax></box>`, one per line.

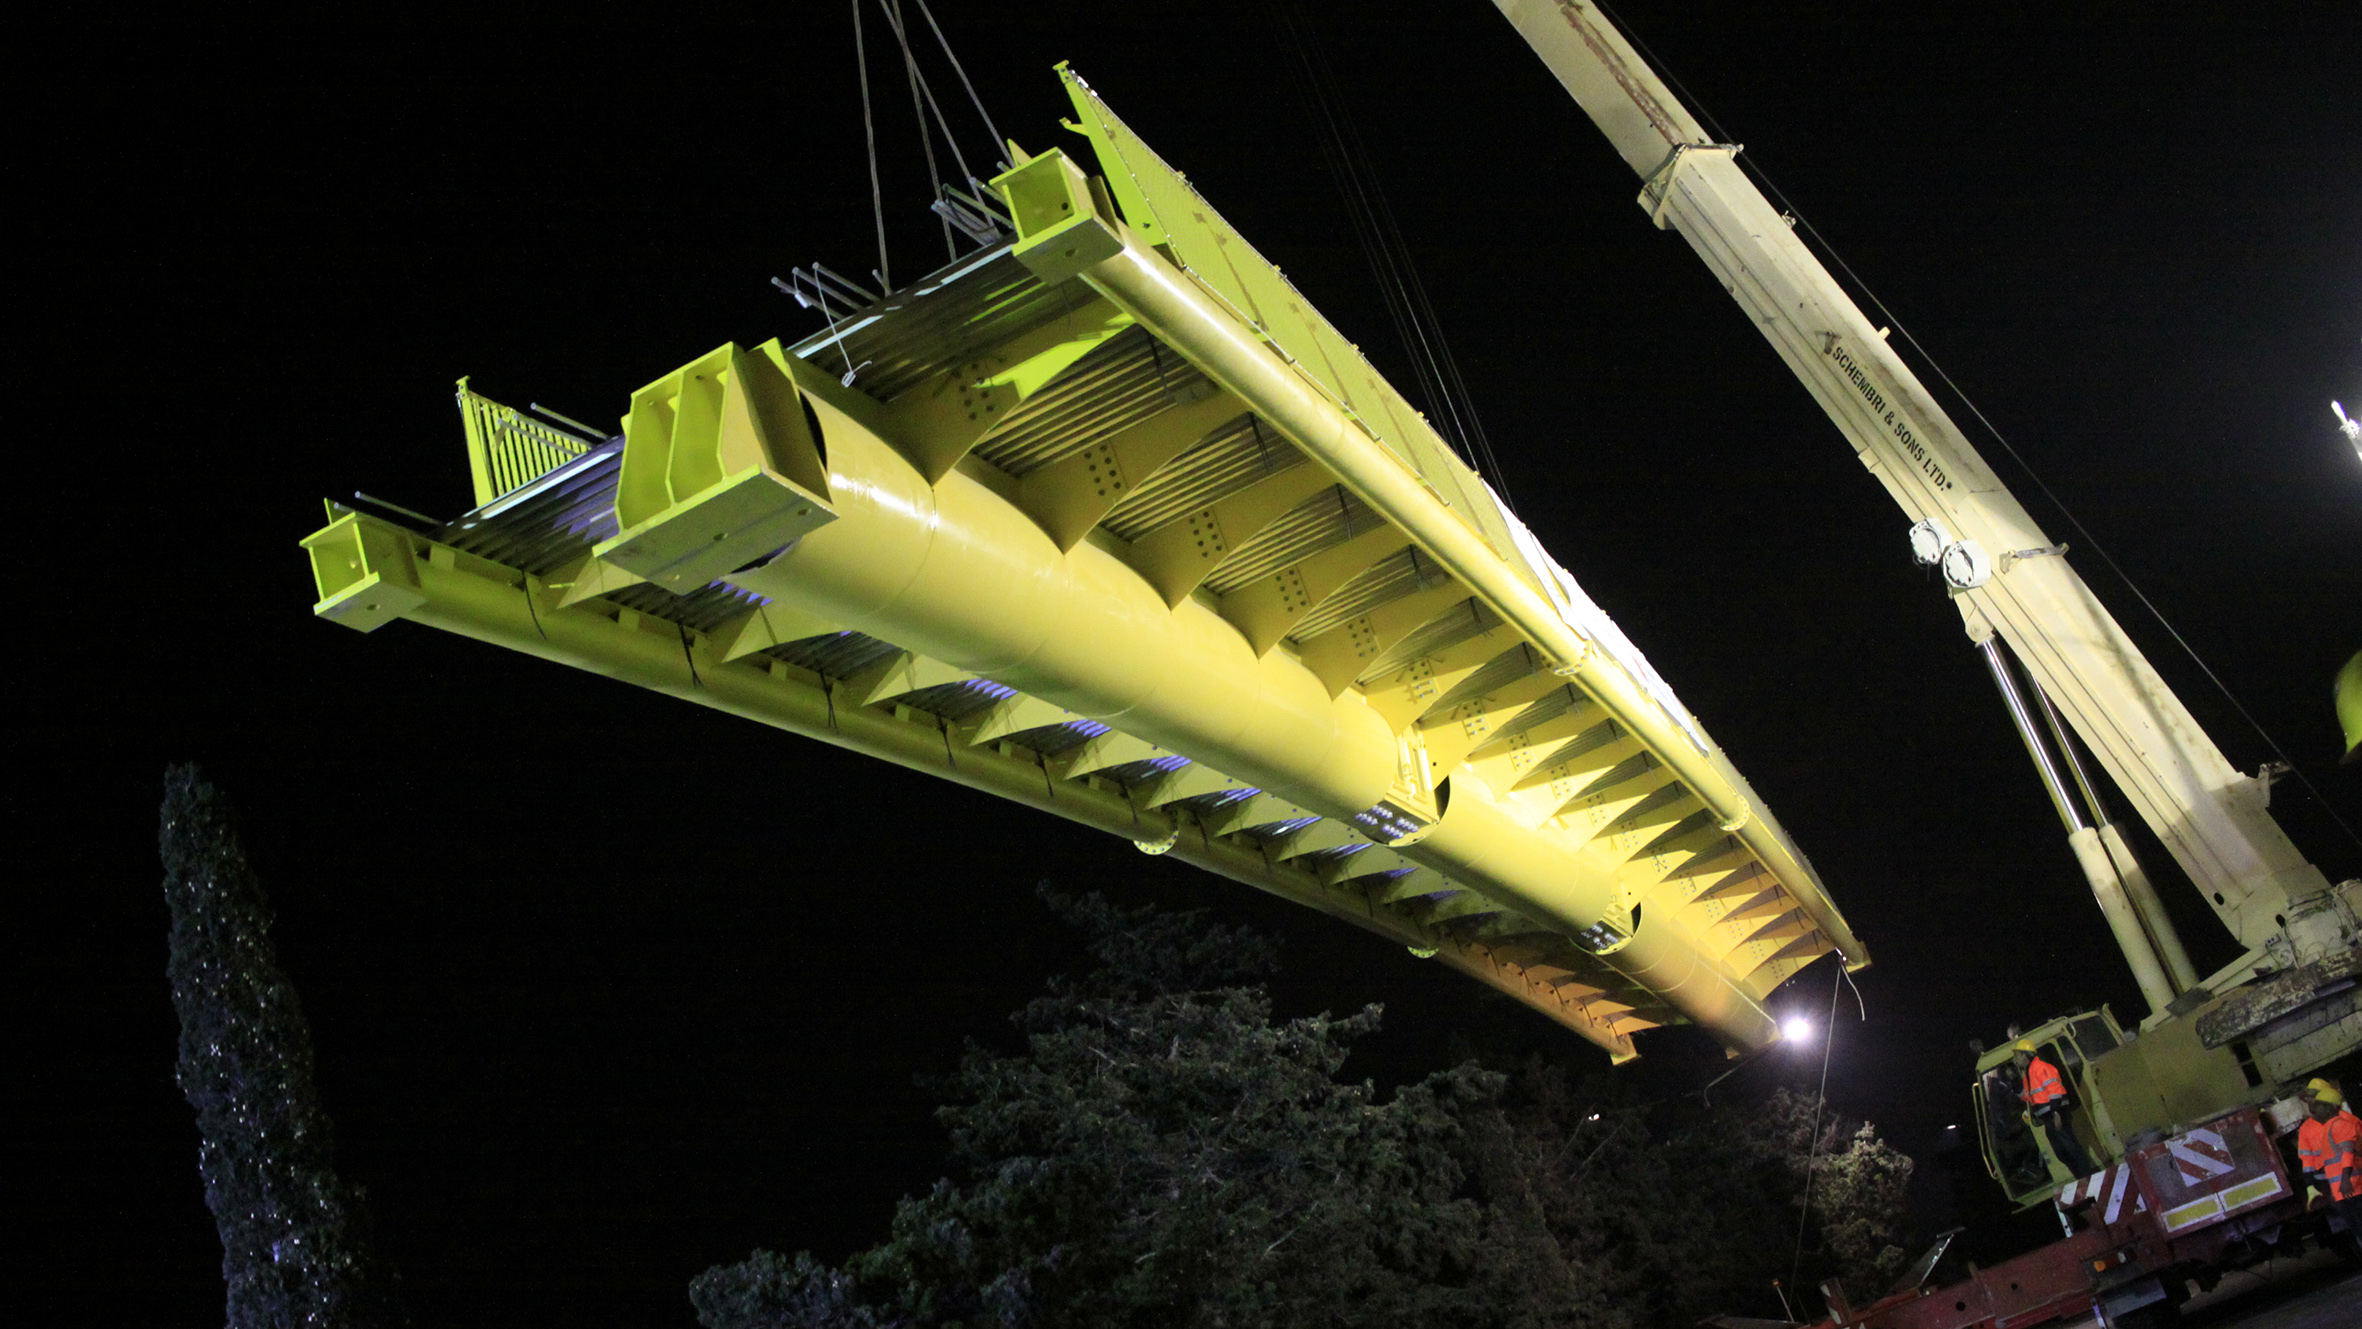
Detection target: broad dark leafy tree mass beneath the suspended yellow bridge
<box><xmin>690</xmin><ymin>897</ymin><xmax>1908</xmax><ymax>1329</ymax></box>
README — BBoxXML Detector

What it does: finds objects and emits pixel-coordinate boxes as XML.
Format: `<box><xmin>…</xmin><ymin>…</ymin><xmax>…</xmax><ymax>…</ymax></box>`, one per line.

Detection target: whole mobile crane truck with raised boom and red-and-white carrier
<box><xmin>1495</xmin><ymin>0</ymin><xmax>2362</xmax><ymax>1329</ymax></box>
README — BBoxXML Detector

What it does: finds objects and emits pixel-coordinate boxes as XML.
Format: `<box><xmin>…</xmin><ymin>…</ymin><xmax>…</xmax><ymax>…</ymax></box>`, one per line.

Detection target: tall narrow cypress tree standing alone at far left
<box><xmin>161</xmin><ymin>765</ymin><xmax>404</xmax><ymax>1329</ymax></box>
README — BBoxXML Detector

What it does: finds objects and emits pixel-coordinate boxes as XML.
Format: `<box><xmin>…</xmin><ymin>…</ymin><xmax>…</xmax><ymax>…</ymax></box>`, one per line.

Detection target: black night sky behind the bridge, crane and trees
<box><xmin>23</xmin><ymin>0</ymin><xmax>2362</xmax><ymax>1327</ymax></box>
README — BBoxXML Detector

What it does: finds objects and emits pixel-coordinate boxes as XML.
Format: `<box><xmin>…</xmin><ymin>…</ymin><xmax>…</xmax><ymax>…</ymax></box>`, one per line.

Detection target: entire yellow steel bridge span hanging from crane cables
<box><xmin>305</xmin><ymin>73</ymin><xmax>1868</xmax><ymax>1060</ymax></box>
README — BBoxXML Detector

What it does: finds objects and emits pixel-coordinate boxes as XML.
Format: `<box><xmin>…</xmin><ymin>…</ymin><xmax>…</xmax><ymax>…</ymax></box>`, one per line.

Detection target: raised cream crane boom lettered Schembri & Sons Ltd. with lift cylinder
<box><xmin>1495</xmin><ymin>0</ymin><xmax>2353</xmax><ymax>1008</ymax></box>
